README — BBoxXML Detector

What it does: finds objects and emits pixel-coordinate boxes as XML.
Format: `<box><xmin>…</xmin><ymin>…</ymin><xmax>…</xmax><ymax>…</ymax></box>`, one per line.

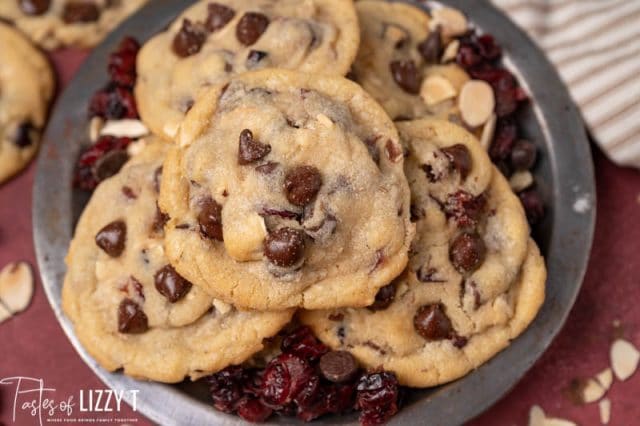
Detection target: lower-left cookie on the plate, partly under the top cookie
<box><xmin>62</xmin><ymin>139</ymin><xmax>292</xmax><ymax>382</ymax></box>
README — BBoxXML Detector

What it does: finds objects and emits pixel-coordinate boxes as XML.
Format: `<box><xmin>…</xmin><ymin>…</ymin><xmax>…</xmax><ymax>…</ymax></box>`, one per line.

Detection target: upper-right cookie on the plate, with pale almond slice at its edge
<box><xmin>351</xmin><ymin>0</ymin><xmax>469</xmax><ymax>120</ymax></box>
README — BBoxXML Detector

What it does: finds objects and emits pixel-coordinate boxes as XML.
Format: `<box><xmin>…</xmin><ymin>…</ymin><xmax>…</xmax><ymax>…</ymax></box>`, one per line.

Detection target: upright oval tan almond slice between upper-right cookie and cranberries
<box><xmin>458</xmin><ymin>80</ymin><xmax>496</xmax><ymax>127</ymax></box>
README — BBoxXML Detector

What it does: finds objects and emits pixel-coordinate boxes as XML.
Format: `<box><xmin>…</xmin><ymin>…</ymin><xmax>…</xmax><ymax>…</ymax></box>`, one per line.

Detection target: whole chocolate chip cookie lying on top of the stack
<box><xmin>160</xmin><ymin>70</ymin><xmax>414</xmax><ymax>310</ymax></box>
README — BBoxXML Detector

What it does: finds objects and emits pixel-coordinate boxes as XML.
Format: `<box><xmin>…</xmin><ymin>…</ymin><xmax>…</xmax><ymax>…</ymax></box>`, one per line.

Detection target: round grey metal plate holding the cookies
<box><xmin>33</xmin><ymin>0</ymin><xmax>596</xmax><ymax>426</ymax></box>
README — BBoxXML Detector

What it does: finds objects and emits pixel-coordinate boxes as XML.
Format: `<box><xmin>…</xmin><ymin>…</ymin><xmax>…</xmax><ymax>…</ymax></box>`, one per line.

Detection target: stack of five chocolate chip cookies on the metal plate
<box><xmin>63</xmin><ymin>0</ymin><xmax>546</xmax><ymax>422</ymax></box>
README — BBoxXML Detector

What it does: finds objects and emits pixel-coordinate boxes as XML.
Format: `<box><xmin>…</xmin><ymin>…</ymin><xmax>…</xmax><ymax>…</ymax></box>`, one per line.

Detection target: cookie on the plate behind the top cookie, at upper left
<box><xmin>136</xmin><ymin>0</ymin><xmax>359</xmax><ymax>139</ymax></box>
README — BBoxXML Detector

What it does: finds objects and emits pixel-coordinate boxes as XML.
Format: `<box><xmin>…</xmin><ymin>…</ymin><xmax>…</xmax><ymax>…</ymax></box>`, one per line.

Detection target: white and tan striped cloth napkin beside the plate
<box><xmin>492</xmin><ymin>0</ymin><xmax>640</xmax><ymax>168</ymax></box>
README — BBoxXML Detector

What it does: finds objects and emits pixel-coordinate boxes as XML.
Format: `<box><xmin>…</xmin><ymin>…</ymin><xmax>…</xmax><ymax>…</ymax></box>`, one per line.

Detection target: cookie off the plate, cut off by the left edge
<box><xmin>0</xmin><ymin>22</ymin><xmax>54</xmax><ymax>183</ymax></box>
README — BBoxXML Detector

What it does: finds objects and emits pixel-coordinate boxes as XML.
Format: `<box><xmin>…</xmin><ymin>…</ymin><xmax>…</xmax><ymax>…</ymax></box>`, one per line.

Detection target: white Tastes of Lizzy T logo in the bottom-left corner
<box><xmin>0</xmin><ymin>376</ymin><xmax>140</xmax><ymax>426</ymax></box>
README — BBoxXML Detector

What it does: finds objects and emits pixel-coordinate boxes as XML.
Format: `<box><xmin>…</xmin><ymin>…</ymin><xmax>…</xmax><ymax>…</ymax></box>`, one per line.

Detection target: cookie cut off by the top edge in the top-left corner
<box><xmin>0</xmin><ymin>0</ymin><xmax>148</xmax><ymax>50</ymax></box>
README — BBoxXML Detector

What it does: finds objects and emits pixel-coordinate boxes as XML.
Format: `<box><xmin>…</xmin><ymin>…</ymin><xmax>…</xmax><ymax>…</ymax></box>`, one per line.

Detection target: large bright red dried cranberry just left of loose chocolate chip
<box><xmin>261</xmin><ymin>353</ymin><xmax>316</xmax><ymax>408</ymax></box>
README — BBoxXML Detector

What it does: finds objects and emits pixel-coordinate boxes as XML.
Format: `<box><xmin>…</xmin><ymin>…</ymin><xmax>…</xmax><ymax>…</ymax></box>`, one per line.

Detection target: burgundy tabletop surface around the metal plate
<box><xmin>0</xmin><ymin>51</ymin><xmax>640</xmax><ymax>426</ymax></box>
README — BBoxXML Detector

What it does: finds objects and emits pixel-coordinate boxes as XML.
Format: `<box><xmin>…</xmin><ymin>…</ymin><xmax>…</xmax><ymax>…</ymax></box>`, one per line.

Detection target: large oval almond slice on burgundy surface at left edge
<box><xmin>0</xmin><ymin>262</ymin><xmax>33</xmax><ymax>314</ymax></box>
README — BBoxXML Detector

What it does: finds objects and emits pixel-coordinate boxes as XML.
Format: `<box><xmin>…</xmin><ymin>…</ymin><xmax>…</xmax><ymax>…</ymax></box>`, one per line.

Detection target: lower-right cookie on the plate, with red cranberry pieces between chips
<box><xmin>300</xmin><ymin>119</ymin><xmax>546</xmax><ymax>387</ymax></box>
